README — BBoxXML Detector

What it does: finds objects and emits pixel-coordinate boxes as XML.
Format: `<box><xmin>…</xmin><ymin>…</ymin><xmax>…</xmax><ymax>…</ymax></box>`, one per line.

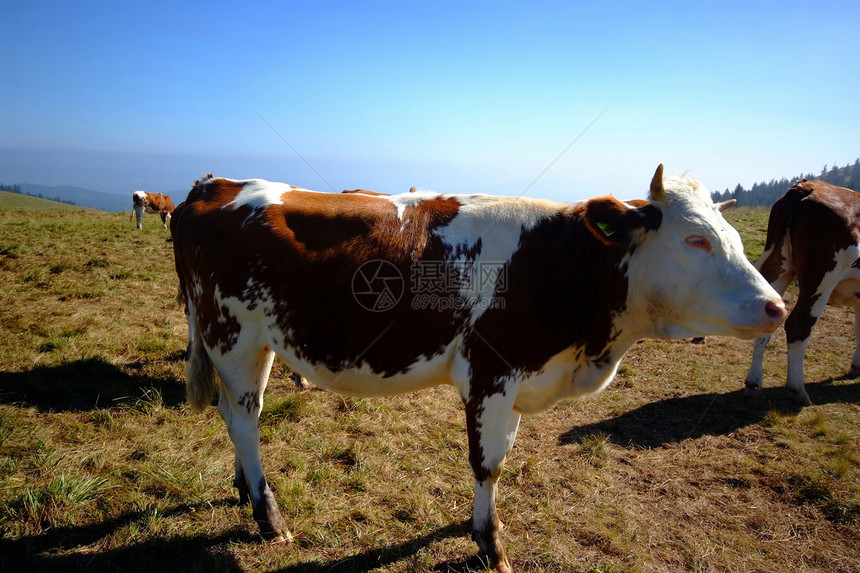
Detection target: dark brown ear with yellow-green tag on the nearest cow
<box><xmin>584</xmin><ymin>197</ymin><xmax>661</xmax><ymax>246</ymax></box>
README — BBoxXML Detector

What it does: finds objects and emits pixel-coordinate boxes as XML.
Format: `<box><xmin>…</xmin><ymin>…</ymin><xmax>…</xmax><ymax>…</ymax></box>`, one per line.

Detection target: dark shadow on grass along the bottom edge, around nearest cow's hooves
<box><xmin>0</xmin><ymin>500</ymin><xmax>484</xmax><ymax>573</ymax></box>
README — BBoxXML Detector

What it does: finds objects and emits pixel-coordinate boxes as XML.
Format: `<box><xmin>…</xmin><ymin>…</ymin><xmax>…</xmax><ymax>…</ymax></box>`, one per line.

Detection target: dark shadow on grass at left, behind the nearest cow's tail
<box><xmin>0</xmin><ymin>352</ymin><xmax>185</xmax><ymax>412</ymax></box>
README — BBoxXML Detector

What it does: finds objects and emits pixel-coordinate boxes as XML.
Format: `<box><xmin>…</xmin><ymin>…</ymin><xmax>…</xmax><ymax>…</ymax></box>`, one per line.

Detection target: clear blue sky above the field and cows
<box><xmin>0</xmin><ymin>0</ymin><xmax>860</xmax><ymax>201</ymax></box>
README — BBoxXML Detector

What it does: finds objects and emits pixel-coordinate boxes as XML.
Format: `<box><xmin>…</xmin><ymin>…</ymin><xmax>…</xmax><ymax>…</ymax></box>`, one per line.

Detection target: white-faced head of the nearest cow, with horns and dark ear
<box><xmin>585</xmin><ymin>165</ymin><xmax>787</xmax><ymax>338</ymax></box>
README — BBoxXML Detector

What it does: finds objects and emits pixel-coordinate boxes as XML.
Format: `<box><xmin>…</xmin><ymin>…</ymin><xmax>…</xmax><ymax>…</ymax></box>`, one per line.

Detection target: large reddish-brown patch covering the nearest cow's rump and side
<box><xmin>171</xmin><ymin>174</ymin><xmax>490</xmax><ymax>375</ymax></box>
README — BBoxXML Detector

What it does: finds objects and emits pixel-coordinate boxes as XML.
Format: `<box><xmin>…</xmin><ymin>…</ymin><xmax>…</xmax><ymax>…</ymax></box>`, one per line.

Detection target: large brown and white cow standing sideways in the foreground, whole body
<box><xmin>171</xmin><ymin>165</ymin><xmax>786</xmax><ymax>571</ymax></box>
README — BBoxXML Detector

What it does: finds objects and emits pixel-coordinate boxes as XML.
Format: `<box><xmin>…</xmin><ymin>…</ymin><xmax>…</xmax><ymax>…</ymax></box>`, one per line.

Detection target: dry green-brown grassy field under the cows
<box><xmin>0</xmin><ymin>196</ymin><xmax>860</xmax><ymax>573</ymax></box>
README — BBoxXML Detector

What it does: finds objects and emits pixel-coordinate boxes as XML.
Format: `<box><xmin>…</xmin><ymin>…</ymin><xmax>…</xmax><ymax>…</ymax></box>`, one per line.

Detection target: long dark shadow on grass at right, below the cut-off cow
<box><xmin>559</xmin><ymin>375</ymin><xmax>860</xmax><ymax>448</ymax></box>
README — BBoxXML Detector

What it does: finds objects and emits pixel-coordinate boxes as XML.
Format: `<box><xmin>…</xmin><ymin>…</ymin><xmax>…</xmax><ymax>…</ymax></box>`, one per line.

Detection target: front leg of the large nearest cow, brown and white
<box><xmin>466</xmin><ymin>390</ymin><xmax>520</xmax><ymax>573</ymax></box>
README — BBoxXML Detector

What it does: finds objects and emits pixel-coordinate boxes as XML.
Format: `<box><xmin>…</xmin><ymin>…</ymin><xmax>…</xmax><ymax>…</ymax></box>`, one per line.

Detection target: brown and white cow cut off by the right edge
<box><xmin>746</xmin><ymin>179</ymin><xmax>860</xmax><ymax>404</ymax></box>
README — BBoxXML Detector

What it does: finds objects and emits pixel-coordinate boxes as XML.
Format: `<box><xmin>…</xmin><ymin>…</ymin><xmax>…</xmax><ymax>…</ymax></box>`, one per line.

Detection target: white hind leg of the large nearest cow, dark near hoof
<box><xmin>218</xmin><ymin>349</ymin><xmax>292</xmax><ymax>542</ymax></box>
